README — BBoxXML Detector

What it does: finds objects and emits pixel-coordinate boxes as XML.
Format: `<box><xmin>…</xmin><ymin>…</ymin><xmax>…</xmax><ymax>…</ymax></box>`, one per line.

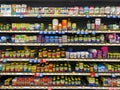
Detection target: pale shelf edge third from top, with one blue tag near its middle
<box><xmin>0</xmin><ymin>43</ymin><xmax>120</xmax><ymax>47</ymax></box>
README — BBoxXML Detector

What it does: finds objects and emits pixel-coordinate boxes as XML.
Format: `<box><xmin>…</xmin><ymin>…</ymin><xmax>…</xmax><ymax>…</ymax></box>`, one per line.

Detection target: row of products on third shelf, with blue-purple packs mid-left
<box><xmin>0</xmin><ymin>33</ymin><xmax>120</xmax><ymax>43</ymax></box>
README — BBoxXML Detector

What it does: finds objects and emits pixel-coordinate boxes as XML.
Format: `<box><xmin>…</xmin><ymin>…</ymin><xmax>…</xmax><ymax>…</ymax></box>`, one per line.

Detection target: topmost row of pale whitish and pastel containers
<box><xmin>0</xmin><ymin>4</ymin><xmax>120</xmax><ymax>15</ymax></box>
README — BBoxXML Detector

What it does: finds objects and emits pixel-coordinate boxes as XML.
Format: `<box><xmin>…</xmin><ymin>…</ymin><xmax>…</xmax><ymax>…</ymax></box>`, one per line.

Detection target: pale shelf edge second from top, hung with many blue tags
<box><xmin>0</xmin><ymin>30</ymin><xmax>120</xmax><ymax>34</ymax></box>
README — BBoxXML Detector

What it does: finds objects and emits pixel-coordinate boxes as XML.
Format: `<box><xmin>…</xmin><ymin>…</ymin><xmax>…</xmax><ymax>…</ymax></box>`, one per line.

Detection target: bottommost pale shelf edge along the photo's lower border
<box><xmin>1</xmin><ymin>86</ymin><xmax>120</xmax><ymax>90</ymax></box>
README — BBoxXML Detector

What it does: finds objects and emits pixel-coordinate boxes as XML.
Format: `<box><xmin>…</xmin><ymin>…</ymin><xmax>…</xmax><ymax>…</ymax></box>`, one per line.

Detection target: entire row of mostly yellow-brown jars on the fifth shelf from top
<box><xmin>0</xmin><ymin>62</ymin><xmax>120</xmax><ymax>73</ymax></box>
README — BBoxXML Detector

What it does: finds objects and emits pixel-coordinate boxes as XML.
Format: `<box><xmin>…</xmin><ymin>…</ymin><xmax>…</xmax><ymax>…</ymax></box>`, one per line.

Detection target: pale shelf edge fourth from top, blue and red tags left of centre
<box><xmin>0</xmin><ymin>58</ymin><xmax>120</xmax><ymax>62</ymax></box>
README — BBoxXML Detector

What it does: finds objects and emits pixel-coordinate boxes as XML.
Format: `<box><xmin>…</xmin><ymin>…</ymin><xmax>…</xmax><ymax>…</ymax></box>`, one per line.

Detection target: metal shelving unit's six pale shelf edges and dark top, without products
<box><xmin>0</xmin><ymin>0</ymin><xmax>120</xmax><ymax>90</ymax></box>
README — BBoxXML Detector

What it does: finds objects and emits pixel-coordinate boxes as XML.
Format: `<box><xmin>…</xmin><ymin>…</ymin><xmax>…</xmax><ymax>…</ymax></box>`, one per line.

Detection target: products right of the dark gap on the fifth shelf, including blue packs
<box><xmin>75</xmin><ymin>62</ymin><xmax>120</xmax><ymax>72</ymax></box>
